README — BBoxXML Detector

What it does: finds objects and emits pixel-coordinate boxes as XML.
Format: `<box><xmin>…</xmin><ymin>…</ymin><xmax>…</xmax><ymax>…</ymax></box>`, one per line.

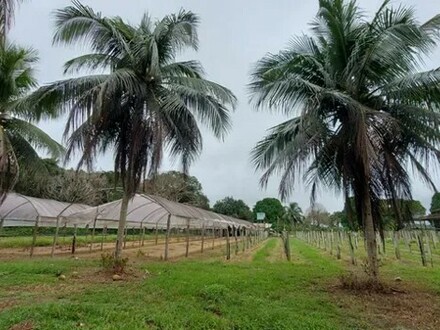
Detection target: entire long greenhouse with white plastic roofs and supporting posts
<box><xmin>0</xmin><ymin>193</ymin><xmax>264</xmax><ymax>260</ymax></box>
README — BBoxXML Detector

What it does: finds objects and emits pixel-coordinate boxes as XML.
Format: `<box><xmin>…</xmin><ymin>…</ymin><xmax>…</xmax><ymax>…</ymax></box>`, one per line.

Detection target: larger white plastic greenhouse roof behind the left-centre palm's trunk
<box><xmin>62</xmin><ymin>194</ymin><xmax>253</xmax><ymax>229</ymax></box>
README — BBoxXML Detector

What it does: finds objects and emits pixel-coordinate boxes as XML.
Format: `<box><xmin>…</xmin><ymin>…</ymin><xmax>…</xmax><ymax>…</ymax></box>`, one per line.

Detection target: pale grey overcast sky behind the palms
<box><xmin>10</xmin><ymin>0</ymin><xmax>440</xmax><ymax>211</ymax></box>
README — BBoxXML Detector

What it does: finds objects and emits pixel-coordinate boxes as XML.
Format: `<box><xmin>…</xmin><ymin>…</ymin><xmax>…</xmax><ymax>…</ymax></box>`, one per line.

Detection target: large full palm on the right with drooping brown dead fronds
<box><xmin>250</xmin><ymin>0</ymin><xmax>440</xmax><ymax>281</ymax></box>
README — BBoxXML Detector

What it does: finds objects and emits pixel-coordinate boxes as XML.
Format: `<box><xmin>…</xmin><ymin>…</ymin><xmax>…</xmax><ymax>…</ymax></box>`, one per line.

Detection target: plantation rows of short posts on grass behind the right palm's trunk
<box><xmin>295</xmin><ymin>229</ymin><xmax>440</xmax><ymax>267</ymax></box>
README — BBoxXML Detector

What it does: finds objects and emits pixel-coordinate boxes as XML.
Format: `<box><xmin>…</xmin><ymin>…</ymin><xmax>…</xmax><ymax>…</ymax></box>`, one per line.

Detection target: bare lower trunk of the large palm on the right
<box><xmin>362</xmin><ymin>186</ymin><xmax>379</xmax><ymax>282</ymax></box>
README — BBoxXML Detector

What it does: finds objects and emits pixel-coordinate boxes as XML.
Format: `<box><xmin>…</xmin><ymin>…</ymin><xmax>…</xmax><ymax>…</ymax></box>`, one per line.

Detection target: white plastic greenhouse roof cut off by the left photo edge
<box><xmin>0</xmin><ymin>193</ymin><xmax>90</xmax><ymax>227</ymax></box>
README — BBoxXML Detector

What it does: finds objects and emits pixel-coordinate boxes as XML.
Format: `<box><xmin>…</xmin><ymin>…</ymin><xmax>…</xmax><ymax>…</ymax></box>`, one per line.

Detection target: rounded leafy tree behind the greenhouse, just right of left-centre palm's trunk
<box><xmin>142</xmin><ymin>171</ymin><xmax>209</xmax><ymax>210</ymax></box>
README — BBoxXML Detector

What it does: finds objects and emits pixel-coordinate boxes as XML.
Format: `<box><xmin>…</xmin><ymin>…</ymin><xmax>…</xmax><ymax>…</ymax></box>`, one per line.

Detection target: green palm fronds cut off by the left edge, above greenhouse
<box><xmin>0</xmin><ymin>44</ymin><xmax>63</xmax><ymax>203</ymax></box>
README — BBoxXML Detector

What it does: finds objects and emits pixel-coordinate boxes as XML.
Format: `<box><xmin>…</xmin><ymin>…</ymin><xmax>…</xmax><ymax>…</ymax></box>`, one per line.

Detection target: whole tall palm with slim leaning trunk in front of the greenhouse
<box><xmin>34</xmin><ymin>1</ymin><xmax>236</xmax><ymax>259</ymax></box>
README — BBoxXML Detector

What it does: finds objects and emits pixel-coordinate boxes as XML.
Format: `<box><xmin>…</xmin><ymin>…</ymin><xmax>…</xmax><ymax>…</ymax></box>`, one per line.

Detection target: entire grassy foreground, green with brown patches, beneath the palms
<box><xmin>0</xmin><ymin>238</ymin><xmax>440</xmax><ymax>329</ymax></box>
